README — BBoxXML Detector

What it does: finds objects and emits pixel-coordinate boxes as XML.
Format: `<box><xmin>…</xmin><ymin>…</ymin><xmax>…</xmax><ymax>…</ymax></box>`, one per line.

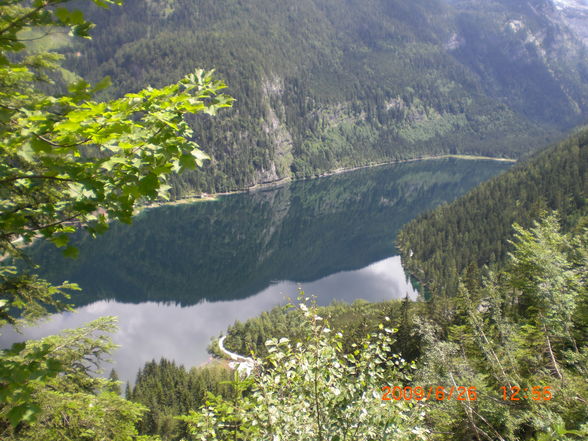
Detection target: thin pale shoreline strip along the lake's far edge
<box><xmin>144</xmin><ymin>154</ymin><xmax>518</xmax><ymax>212</ymax></box>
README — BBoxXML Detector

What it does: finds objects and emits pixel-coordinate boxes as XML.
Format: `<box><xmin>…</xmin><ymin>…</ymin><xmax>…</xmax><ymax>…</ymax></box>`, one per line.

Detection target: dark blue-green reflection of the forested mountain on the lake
<box><xmin>27</xmin><ymin>160</ymin><xmax>507</xmax><ymax>306</ymax></box>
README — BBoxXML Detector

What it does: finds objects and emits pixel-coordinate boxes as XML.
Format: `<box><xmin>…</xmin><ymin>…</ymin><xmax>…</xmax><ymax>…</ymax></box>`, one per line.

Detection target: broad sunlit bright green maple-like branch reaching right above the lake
<box><xmin>0</xmin><ymin>49</ymin><xmax>230</xmax><ymax>253</ymax></box>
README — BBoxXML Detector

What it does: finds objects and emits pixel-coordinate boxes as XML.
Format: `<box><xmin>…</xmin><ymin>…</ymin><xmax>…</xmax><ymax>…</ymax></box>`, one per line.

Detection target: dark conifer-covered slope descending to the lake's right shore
<box><xmin>397</xmin><ymin>124</ymin><xmax>588</xmax><ymax>295</ymax></box>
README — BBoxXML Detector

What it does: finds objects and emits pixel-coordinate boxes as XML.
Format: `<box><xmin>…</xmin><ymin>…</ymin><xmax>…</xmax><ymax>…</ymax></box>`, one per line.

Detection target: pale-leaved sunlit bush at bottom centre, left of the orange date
<box><xmin>182</xmin><ymin>296</ymin><xmax>427</xmax><ymax>440</ymax></box>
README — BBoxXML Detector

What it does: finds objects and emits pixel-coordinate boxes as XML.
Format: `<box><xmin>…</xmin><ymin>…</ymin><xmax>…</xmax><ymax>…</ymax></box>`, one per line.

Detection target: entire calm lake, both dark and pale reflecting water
<box><xmin>0</xmin><ymin>159</ymin><xmax>510</xmax><ymax>381</ymax></box>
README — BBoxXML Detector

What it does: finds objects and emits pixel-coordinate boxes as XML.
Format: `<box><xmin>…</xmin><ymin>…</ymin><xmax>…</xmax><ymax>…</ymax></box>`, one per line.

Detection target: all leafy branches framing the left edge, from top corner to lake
<box><xmin>0</xmin><ymin>0</ymin><xmax>232</xmax><ymax>321</ymax></box>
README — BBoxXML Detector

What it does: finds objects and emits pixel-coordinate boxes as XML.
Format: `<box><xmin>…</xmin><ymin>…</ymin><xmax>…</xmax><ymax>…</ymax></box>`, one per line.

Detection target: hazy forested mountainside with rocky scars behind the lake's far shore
<box><xmin>66</xmin><ymin>0</ymin><xmax>588</xmax><ymax>193</ymax></box>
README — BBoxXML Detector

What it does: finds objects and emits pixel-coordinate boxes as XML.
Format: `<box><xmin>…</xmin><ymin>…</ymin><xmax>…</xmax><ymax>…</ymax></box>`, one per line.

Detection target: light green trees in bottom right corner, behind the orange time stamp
<box><xmin>415</xmin><ymin>212</ymin><xmax>588</xmax><ymax>441</ymax></box>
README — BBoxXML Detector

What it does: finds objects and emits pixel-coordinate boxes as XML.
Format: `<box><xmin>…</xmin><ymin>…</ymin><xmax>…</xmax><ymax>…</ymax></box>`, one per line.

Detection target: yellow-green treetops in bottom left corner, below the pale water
<box><xmin>0</xmin><ymin>317</ymin><xmax>160</xmax><ymax>441</ymax></box>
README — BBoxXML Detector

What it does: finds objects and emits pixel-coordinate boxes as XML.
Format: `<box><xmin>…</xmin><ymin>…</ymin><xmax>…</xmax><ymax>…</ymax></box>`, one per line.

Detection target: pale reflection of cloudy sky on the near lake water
<box><xmin>2</xmin><ymin>256</ymin><xmax>417</xmax><ymax>381</ymax></box>
